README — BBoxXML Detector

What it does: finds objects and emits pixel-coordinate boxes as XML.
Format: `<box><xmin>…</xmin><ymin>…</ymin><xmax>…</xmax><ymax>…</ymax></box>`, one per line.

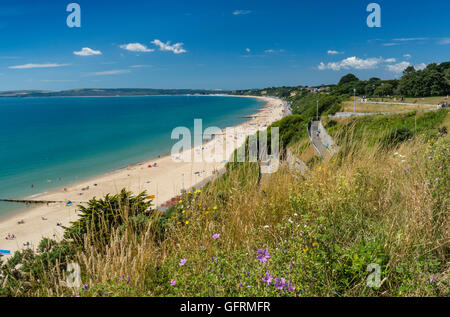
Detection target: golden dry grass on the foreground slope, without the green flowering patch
<box><xmin>51</xmin><ymin>127</ymin><xmax>450</xmax><ymax>296</ymax></box>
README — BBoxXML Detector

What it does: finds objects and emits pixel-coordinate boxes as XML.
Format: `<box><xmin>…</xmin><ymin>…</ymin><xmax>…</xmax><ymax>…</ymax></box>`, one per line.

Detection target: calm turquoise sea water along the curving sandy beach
<box><xmin>0</xmin><ymin>96</ymin><xmax>262</xmax><ymax>217</ymax></box>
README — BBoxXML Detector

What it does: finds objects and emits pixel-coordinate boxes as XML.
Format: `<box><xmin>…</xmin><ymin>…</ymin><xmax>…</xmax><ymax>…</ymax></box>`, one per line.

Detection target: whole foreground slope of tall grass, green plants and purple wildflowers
<box><xmin>1</xmin><ymin>111</ymin><xmax>450</xmax><ymax>296</ymax></box>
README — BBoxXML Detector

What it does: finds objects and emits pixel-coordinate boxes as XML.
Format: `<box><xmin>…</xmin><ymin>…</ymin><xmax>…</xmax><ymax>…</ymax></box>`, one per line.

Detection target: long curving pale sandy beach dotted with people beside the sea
<box><xmin>0</xmin><ymin>97</ymin><xmax>289</xmax><ymax>259</ymax></box>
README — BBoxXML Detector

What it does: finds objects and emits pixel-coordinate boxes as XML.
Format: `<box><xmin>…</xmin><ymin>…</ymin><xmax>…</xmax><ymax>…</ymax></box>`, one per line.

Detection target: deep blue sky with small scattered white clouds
<box><xmin>0</xmin><ymin>0</ymin><xmax>450</xmax><ymax>90</ymax></box>
